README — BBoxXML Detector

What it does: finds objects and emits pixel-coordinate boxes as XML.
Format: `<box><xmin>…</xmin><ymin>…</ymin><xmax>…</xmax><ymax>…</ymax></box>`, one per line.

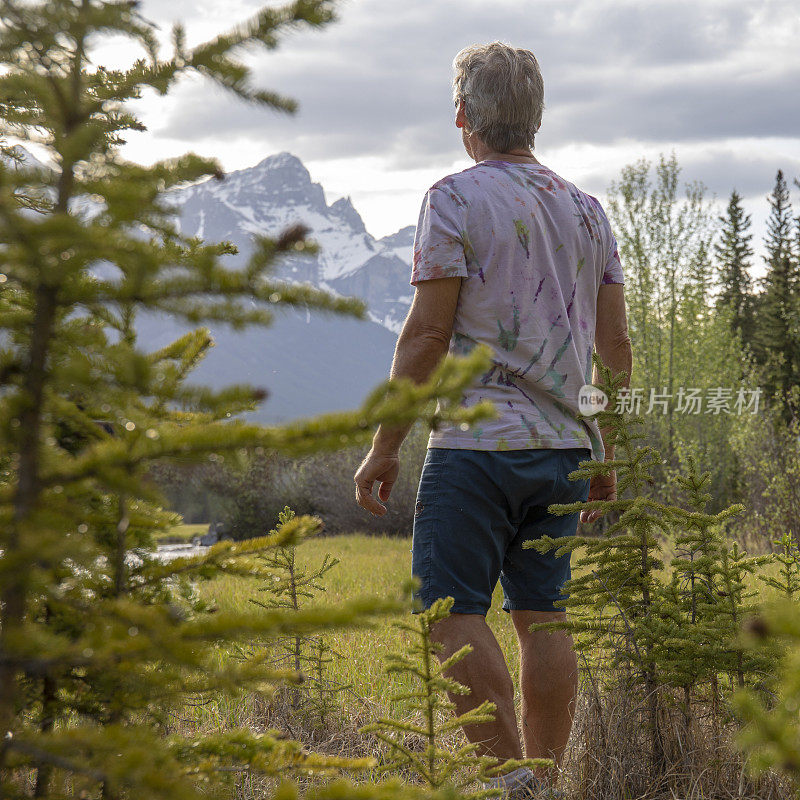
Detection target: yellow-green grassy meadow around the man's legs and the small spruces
<box><xmin>167</xmin><ymin>531</ymin><xmax>787</xmax><ymax>800</ymax></box>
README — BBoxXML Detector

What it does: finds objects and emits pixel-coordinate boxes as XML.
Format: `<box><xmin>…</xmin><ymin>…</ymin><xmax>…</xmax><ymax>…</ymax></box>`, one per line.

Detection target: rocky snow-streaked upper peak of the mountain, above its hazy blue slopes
<box><xmin>176</xmin><ymin>152</ymin><xmax>414</xmax><ymax>333</ymax></box>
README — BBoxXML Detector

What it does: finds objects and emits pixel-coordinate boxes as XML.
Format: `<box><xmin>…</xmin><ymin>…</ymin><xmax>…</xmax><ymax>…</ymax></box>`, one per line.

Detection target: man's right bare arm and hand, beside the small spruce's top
<box><xmin>581</xmin><ymin>283</ymin><xmax>633</xmax><ymax>522</ymax></box>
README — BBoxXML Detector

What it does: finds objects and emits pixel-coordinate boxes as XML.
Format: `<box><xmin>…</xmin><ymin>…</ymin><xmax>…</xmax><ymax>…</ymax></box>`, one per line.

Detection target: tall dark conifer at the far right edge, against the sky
<box><xmin>755</xmin><ymin>170</ymin><xmax>800</xmax><ymax>412</ymax></box>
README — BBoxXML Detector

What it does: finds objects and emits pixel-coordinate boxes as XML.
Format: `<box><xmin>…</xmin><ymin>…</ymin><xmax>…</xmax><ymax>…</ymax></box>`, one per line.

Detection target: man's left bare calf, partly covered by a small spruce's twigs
<box><xmin>432</xmin><ymin>614</ymin><xmax>522</xmax><ymax>760</ymax></box>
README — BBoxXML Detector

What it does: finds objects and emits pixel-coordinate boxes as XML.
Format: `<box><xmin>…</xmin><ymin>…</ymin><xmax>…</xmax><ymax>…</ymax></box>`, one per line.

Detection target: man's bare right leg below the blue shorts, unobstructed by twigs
<box><xmin>511</xmin><ymin>611</ymin><xmax>578</xmax><ymax>784</ymax></box>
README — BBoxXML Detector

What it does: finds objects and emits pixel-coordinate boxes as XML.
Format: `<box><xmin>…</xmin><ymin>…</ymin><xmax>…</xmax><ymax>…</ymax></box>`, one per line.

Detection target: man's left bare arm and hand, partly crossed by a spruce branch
<box><xmin>354</xmin><ymin>277</ymin><xmax>461</xmax><ymax>516</ymax></box>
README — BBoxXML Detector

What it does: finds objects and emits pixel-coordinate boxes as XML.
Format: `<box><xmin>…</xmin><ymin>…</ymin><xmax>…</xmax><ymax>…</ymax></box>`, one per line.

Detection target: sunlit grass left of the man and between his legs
<box><xmin>173</xmin><ymin>526</ymin><xmax>532</xmax><ymax>800</ymax></box>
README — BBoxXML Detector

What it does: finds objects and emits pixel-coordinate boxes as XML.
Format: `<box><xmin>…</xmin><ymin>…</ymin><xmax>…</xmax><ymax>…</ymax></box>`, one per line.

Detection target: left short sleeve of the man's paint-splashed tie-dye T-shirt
<box><xmin>411</xmin><ymin>186</ymin><xmax>468</xmax><ymax>286</ymax></box>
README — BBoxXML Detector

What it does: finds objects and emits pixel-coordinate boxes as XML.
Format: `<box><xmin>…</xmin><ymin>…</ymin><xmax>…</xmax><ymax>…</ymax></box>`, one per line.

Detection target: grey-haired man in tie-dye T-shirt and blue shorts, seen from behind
<box><xmin>355</xmin><ymin>42</ymin><xmax>631</xmax><ymax>796</ymax></box>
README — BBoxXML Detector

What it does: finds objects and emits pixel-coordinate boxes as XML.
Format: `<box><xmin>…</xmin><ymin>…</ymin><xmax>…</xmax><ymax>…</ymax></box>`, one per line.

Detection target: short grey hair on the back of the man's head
<box><xmin>453</xmin><ymin>41</ymin><xmax>544</xmax><ymax>153</ymax></box>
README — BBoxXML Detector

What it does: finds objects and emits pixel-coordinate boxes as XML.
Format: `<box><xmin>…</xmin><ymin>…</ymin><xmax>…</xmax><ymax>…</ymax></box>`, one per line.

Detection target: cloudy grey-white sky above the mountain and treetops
<box><xmin>97</xmin><ymin>0</ymin><xmax>800</xmax><ymax>271</ymax></box>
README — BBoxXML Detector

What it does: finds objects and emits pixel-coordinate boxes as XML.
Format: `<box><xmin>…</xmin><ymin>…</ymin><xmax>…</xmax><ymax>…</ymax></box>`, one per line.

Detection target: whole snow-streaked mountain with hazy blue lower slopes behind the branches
<box><xmin>6</xmin><ymin>147</ymin><xmax>414</xmax><ymax>423</ymax></box>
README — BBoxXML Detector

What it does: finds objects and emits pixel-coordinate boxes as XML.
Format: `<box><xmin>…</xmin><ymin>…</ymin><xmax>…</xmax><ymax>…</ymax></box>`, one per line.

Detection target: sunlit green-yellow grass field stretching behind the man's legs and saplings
<box><xmin>167</xmin><ymin>526</ymin><xmax>788</xmax><ymax>798</ymax></box>
